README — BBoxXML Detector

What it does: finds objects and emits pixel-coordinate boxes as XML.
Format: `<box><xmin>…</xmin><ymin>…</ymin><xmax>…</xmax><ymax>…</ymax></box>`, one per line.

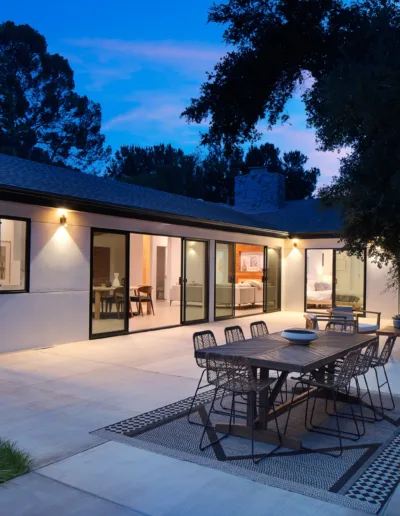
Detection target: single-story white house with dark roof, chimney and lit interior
<box><xmin>0</xmin><ymin>155</ymin><xmax>397</xmax><ymax>352</ymax></box>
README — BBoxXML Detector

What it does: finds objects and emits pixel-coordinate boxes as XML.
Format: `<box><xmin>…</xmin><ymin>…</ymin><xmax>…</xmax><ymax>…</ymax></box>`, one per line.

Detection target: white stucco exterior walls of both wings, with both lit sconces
<box><xmin>0</xmin><ymin>201</ymin><xmax>398</xmax><ymax>352</ymax></box>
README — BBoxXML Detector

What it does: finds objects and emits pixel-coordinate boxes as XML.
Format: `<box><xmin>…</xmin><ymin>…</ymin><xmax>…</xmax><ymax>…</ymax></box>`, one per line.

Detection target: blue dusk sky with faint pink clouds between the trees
<box><xmin>1</xmin><ymin>0</ymin><xmax>339</xmax><ymax>183</ymax></box>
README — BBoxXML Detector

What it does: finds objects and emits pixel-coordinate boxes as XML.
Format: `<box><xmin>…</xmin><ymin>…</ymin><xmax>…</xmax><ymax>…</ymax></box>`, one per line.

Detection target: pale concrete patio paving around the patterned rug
<box><xmin>0</xmin><ymin>312</ymin><xmax>400</xmax><ymax>516</ymax></box>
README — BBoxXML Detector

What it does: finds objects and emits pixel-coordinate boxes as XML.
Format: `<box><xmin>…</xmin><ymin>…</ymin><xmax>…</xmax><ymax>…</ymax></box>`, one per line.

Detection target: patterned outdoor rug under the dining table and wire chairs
<box><xmin>93</xmin><ymin>392</ymin><xmax>400</xmax><ymax>514</ymax></box>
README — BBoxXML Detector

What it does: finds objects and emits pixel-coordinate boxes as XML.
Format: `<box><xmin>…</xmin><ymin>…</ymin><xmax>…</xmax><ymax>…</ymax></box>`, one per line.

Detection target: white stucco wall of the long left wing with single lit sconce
<box><xmin>0</xmin><ymin>201</ymin><xmax>284</xmax><ymax>352</ymax></box>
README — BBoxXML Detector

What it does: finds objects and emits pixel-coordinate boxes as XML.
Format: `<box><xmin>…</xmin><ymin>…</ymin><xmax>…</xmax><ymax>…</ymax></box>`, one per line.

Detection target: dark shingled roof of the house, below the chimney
<box><xmin>0</xmin><ymin>154</ymin><xmax>340</xmax><ymax>232</ymax></box>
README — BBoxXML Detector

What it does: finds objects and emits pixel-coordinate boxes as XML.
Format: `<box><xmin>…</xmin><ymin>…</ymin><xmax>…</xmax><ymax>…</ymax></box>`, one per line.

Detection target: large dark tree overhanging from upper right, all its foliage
<box><xmin>183</xmin><ymin>0</ymin><xmax>400</xmax><ymax>286</ymax></box>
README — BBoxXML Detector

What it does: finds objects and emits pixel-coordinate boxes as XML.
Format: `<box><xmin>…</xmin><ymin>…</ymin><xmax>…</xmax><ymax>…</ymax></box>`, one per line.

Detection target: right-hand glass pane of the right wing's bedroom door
<box><xmin>336</xmin><ymin>251</ymin><xmax>364</xmax><ymax>310</ymax></box>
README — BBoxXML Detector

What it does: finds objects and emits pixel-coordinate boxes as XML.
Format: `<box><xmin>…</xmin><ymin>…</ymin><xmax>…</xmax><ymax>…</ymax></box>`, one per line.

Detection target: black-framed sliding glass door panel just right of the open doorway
<box><xmin>180</xmin><ymin>238</ymin><xmax>208</xmax><ymax>324</ymax></box>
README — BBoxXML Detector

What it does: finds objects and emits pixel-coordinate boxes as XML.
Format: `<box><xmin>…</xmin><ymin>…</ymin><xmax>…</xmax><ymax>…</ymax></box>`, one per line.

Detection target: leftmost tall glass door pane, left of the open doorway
<box><xmin>92</xmin><ymin>232</ymin><xmax>126</xmax><ymax>335</ymax></box>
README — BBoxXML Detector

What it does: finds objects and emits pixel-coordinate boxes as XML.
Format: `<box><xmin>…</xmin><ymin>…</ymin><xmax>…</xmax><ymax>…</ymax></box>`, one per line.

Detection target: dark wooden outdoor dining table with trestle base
<box><xmin>195</xmin><ymin>328</ymin><xmax>376</xmax><ymax>450</ymax></box>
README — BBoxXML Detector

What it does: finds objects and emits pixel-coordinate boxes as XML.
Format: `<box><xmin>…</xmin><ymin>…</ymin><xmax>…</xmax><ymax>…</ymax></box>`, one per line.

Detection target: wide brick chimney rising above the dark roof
<box><xmin>234</xmin><ymin>167</ymin><xmax>285</xmax><ymax>213</ymax></box>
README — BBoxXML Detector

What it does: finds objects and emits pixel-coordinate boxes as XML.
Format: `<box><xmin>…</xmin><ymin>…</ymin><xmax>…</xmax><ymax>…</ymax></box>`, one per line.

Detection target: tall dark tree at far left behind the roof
<box><xmin>0</xmin><ymin>21</ymin><xmax>111</xmax><ymax>169</ymax></box>
